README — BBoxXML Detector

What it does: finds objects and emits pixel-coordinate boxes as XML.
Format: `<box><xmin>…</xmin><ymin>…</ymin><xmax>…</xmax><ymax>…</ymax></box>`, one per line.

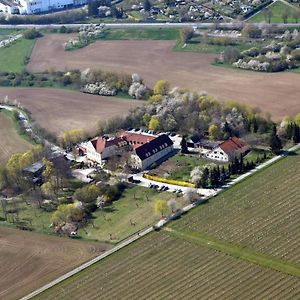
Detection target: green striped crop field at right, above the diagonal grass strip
<box><xmin>173</xmin><ymin>152</ymin><xmax>300</xmax><ymax>265</ymax></box>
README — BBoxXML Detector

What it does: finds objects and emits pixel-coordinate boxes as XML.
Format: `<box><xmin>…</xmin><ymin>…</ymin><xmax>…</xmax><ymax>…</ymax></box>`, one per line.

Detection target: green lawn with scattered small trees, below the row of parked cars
<box><xmin>78</xmin><ymin>186</ymin><xmax>185</xmax><ymax>243</ymax></box>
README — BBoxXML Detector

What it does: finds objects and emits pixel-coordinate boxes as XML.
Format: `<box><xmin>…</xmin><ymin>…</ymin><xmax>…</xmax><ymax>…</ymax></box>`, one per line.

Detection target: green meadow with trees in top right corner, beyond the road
<box><xmin>249</xmin><ymin>1</ymin><xmax>300</xmax><ymax>23</ymax></box>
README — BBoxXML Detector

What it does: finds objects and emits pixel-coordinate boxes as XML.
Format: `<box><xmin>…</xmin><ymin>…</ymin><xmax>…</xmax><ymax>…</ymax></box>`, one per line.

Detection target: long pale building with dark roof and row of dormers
<box><xmin>130</xmin><ymin>134</ymin><xmax>173</xmax><ymax>170</ymax></box>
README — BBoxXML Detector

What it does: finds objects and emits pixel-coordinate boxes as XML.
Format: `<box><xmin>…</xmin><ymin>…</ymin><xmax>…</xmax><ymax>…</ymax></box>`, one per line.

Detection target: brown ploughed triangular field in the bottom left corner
<box><xmin>0</xmin><ymin>227</ymin><xmax>110</xmax><ymax>300</ymax></box>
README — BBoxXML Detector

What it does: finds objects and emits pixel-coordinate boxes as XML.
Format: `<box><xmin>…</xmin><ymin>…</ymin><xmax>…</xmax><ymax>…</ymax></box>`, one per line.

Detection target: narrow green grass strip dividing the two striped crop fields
<box><xmin>165</xmin><ymin>227</ymin><xmax>300</xmax><ymax>278</ymax></box>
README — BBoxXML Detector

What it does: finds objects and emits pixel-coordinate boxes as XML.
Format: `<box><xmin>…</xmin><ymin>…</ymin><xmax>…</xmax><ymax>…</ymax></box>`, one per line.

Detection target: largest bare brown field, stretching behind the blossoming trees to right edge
<box><xmin>28</xmin><ymin>35</ymin><xmax>300</xmax><ymax>119</ymax></box>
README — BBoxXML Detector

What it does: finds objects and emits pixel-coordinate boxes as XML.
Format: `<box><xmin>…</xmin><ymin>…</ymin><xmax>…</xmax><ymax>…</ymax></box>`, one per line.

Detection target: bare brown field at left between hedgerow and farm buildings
<box><xmin>0</xmin><ymin>88</ymin><xmax>143</xmax><ymax>135</ymax></box>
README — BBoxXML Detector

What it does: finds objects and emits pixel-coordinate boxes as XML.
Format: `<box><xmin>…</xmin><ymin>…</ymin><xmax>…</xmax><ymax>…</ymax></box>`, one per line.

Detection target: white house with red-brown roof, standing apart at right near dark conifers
<box><xmin>205</xmin><ymin>137</ymin><xmax>250</xmax><ymax>162</ymax></box>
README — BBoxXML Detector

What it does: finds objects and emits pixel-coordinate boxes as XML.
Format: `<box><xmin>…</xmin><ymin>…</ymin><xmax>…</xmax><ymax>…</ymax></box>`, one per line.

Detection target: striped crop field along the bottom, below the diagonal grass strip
<box><xmin>36</xmin><ymin>231</ymin><xmax>300</xmax><ymax>300</ymax></box>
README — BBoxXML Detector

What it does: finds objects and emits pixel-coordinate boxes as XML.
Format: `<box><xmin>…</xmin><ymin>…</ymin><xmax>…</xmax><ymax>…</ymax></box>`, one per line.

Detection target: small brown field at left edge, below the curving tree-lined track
<box><xmin>0</xmin><ymin>112</ymin><xmax>31</xmax><ymax>165</ymax></box>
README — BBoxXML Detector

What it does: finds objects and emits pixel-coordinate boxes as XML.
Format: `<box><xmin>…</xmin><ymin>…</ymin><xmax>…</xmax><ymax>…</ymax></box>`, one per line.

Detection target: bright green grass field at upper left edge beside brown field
<box><xmin>0</xmin><ymin>38</ymin><xmax>35</xmax><ymax>73</ymax></box>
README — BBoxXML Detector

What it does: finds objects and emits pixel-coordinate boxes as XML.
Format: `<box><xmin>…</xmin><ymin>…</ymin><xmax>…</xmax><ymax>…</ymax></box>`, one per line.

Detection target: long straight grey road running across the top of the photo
<box><xmin>0</xmin><ymin>22</ymin><xmax>300</xmax><ymax>29</ymax></box>
